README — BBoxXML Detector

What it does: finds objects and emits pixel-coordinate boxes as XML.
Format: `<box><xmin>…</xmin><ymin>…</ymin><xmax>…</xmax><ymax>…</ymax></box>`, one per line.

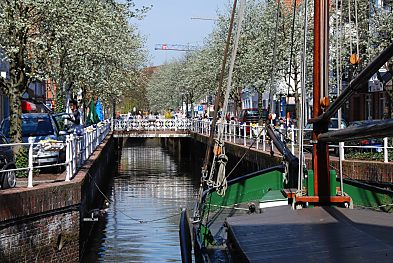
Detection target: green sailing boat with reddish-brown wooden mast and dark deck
<box><xmin>179</xmin><ymin>1</ymin><xmax>393</xmax><ymax>262</ymax></box>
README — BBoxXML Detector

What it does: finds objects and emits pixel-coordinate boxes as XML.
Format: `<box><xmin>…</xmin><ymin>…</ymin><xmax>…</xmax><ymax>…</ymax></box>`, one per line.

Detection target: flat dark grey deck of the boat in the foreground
<box><xmin>227</xmin><ymin>206</ymin><xmax>393</xmax><ymax>263</ymax></box>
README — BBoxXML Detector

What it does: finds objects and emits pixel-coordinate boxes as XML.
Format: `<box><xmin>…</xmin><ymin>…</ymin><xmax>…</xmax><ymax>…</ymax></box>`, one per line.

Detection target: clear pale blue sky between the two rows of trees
<box><xmin>131</xmin><ymin>0</ymin><xmax>233</xmax><ymax>66</ymax></box>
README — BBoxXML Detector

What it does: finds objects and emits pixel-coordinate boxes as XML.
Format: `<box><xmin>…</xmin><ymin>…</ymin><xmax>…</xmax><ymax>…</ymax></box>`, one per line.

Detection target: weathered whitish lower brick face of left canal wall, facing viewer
<box><xmin>0</xmin><ymin>210</ymin><xmax>79</xmax><ymax>262</ymax></box>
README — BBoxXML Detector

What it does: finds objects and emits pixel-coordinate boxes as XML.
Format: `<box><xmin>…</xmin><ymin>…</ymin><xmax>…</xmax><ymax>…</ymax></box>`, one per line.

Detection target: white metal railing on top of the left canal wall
<box><xmin>0</xmin><ymin>120</ymin><xmax>111</xmax><ymax>190</ymax></box>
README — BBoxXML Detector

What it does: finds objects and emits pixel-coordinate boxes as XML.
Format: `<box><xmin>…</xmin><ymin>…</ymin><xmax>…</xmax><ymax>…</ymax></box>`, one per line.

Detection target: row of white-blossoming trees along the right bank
<box><xmin>147</xmin><ymin>0</ymin><xmax>393</xmax><ymax>119</ymax></box>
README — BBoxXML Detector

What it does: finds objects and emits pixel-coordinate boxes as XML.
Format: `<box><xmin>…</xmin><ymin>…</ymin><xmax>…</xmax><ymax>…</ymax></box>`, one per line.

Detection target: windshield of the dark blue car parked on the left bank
<box><xmin>2</xmin><ymin>116</ymin><xmax>54</xmax><ymax>137</ymax></box>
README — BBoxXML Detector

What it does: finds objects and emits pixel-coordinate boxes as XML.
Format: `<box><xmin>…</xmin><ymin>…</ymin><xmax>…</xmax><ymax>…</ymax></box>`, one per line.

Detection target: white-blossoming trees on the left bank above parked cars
<box><xmin>0</xmin><ymin>0</ymin><xmax>148</xmax><ymax>142</ymax></box>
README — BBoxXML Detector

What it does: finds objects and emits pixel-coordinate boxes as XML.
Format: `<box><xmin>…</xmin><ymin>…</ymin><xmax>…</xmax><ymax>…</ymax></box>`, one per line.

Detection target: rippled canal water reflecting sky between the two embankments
<box><xmin>81</xmin><ymin>139</ymin><xmax>201</xmax><ymax>262</ymax></box>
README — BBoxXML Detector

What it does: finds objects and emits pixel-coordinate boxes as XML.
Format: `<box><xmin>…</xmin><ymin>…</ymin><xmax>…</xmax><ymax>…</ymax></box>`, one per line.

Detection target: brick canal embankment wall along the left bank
<box><xmin>0</xmin><ymin>133</ymin><xmax>116</xmax><ymax>262</ymax></box>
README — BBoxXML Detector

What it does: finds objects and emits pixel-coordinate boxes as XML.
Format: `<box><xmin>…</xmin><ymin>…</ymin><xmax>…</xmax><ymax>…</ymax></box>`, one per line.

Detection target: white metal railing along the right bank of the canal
<box><xmin>190</xmin><ymin>119</ymin><xmax>393</xmax><ymax>163</ymax></box>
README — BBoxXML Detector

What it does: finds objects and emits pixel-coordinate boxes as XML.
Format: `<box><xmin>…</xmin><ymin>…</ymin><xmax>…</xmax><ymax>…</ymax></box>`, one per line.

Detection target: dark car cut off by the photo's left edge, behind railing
<box><xmin>0</xmin><ymin>134</ymin><xmax>16</xmax><ymax>189</ymax></box>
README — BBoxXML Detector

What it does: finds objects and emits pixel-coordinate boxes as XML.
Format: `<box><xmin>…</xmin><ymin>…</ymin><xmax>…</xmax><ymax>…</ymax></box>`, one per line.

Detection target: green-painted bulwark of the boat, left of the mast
<box><xmin>206</xmin><ymin>171</ymin><xmax>284</xmax><ymax>207</ymax></box>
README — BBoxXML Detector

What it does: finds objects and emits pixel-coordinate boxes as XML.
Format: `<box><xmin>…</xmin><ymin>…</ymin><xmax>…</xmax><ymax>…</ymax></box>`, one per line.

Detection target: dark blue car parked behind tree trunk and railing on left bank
<box><xmin>1</xmin><ymin>113</ymin><xmax>67</xmax><ymax>165</ymax></box>
